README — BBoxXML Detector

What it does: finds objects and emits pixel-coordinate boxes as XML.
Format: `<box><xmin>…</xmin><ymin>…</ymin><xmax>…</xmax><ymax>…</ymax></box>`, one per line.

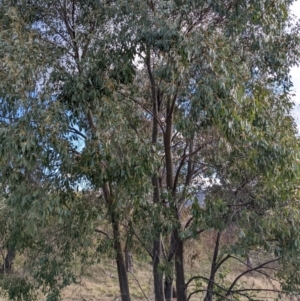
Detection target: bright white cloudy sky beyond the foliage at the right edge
<box><xmin>291</xmin><ymin>0</ymin><xmax>300</xmax><ymax>133</ymax></box>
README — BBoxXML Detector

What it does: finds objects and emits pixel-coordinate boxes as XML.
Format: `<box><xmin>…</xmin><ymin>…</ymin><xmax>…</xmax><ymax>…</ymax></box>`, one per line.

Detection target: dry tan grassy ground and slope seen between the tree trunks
<box><xmin>0</xmin><ymin>233</ymin><xmax>279</xmax><ymax>301</ymax></box>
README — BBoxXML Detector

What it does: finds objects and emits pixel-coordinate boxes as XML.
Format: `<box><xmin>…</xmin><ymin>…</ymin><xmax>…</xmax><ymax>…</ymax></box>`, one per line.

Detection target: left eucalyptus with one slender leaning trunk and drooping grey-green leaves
<box><xmin>1</xmin><ymin>1</ymin><xmax>153</xmax><ymax>300</ymax></box>
